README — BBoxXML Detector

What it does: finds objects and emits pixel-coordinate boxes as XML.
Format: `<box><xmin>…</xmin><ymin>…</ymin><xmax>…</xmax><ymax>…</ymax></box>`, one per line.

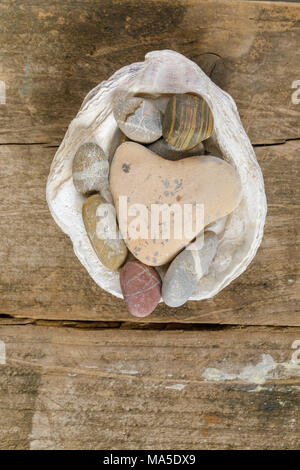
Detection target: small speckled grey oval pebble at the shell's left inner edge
<box><xmin>73</xmin><ymin>143</ymin><xmax>109</xmax><ymax>195</ymax></box>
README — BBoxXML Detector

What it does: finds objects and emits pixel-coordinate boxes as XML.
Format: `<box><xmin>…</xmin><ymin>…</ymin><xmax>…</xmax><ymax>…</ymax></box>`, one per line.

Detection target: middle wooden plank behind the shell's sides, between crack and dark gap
<box><xmin>0</xmin><ymin>142</ymin><xmax>300</xmax><ymax>326</ymax></box>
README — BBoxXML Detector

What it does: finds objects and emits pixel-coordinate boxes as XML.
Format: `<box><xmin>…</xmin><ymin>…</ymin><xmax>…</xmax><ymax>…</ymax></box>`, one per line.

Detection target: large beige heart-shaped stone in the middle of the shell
<box><xmin>110</xmin><ymin>142</ymin><xmax>241</xmax><ymax>266</ymax></box>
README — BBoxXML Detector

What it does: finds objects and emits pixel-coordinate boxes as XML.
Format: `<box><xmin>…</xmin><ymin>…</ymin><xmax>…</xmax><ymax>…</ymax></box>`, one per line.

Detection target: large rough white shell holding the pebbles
<box><xmin>47</xmin><ymin>50</ymin><xmax>267</xmax><ymax>300</ymax></box>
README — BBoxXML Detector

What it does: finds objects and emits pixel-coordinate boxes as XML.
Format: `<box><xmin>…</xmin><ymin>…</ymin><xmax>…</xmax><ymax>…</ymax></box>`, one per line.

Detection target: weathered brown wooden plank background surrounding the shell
<box><xmin>0</xmin><ymin>0</ymin><xmax>300</xmax><ymax>449</ymax></box>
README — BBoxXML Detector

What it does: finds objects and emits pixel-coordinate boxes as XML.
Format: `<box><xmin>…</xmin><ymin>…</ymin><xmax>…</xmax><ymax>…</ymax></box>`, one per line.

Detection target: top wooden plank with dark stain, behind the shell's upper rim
<box><xmin>0</xmin><ymin>0</ymin><xmax>300</xmax><ymax>145</ymax></box>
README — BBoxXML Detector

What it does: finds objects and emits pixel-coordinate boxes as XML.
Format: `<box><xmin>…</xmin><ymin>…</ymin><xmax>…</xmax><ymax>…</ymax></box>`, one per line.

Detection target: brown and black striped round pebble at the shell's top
<box><xmin>163</xmin><ymin>94</ymin><xmax>213</xmax><ymax>150</ymax></box>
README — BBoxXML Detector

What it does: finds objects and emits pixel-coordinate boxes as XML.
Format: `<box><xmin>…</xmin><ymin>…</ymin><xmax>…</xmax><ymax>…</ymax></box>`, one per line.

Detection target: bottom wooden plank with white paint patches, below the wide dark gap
<box><xmin>0</xmin><ymin>325</ymin><xmax>300</xmax><ymax>449</ymax></box>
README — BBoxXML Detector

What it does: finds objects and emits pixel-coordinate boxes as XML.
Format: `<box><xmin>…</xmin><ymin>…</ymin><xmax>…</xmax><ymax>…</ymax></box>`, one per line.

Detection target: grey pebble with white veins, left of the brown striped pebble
<box><xmin>113</xmin><ymin>94</ymin><xmax>162</xmax><ymax>144</ymax></box>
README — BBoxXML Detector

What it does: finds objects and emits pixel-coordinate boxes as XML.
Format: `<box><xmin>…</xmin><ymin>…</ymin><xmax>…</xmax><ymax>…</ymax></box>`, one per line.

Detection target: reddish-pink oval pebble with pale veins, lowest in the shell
<box><xmin>120</xmin><ymin>260</ymin><xmax>161</xmax><ymax>317</ymax></box>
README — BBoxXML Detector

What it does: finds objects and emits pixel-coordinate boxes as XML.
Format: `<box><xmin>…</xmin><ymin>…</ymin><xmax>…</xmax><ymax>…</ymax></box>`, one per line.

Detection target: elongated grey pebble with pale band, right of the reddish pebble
<box><xmin>162</xmin><ymin>232</ymin><xmax>218</xmax><ymax>307</ymax></box>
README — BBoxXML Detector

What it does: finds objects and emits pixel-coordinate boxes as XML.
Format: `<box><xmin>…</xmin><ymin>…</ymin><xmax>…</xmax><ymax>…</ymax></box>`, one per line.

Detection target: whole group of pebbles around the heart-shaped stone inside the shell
<box><xmin>73</xmin><ymin>91</ymin><xmax>241</xmax><ymax>317</ymax></box>
